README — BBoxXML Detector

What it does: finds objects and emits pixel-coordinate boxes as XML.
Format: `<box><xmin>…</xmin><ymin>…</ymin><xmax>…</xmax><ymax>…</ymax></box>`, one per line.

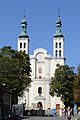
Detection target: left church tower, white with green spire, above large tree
<box><xmin>18</xmin><ymin>15</ymin><xmax>29</xmax><ymax>54</ymax></box>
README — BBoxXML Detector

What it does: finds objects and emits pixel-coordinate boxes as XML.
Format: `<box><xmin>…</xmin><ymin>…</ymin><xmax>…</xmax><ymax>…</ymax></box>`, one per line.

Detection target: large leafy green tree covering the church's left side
<box><xmin>0</xmin><ymin>46</ymin><xmax>31</xmax><ymax>102</ymax></box>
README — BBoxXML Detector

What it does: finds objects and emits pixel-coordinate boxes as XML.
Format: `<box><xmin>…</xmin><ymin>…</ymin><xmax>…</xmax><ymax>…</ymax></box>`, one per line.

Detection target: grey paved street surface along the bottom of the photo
<box><xmin>23</xmin><ymin>116</ymin><xmax>76</xmax><ymax>120</ymax></box>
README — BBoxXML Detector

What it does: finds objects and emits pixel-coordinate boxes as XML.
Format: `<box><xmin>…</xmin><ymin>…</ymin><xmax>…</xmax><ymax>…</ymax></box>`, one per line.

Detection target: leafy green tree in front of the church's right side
<box><xmin>50</xmin><ymin>65</ymin><xmax>74</xmax><ymax>107</ymax></box>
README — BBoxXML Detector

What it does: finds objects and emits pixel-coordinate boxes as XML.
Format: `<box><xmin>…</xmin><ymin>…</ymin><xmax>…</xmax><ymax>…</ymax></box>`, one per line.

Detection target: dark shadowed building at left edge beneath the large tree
<box><xmin>0</xmin><ymin>84</ymin><xmax>11</xmax><ymax>116</ymax></box>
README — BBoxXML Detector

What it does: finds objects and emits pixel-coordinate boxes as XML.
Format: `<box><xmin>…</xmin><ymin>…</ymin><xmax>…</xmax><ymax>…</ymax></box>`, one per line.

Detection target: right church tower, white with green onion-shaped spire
<box><xmin>53</xmin><ymin>15</ymin><xmax>64</xmax><ymax>58</ymax></box>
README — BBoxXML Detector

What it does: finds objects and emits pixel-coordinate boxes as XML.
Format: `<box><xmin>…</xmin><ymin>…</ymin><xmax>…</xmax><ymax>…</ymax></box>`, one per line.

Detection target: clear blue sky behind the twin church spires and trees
<box><xmin>0</xmin><ymin>0</ymin><xmax>80</xmax><ymax>67</ymax></box>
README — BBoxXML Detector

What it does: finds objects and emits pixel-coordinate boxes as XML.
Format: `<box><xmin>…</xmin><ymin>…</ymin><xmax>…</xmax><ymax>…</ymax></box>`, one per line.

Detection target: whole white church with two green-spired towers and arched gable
<box><xmin>18</xmin><ymin>13</ymin><xmax>65</xmax><ymax>114</ymax></box>
